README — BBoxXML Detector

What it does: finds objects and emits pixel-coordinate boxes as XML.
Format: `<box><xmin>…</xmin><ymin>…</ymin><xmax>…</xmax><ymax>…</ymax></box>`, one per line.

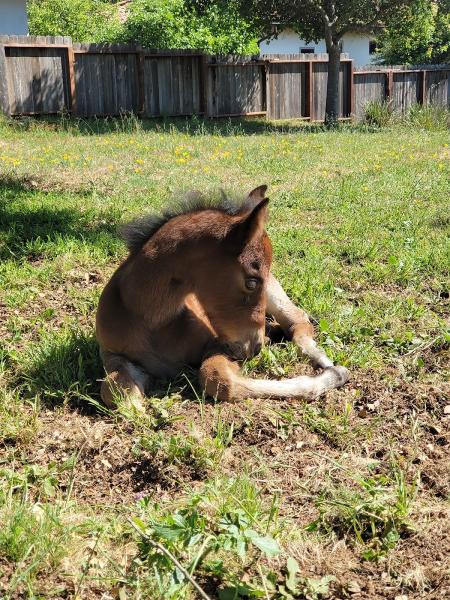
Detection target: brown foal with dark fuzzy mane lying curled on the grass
<box><xmin>97</xmin><ymin>186</ymin><xmax>348</xmax><ymax>407</ymax></box>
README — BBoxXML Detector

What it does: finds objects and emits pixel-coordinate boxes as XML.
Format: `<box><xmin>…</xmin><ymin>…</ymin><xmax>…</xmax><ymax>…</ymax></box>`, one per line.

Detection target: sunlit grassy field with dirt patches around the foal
<box><xmin>0</xmin><ymin>113</ymin><xmax>450</xmax><ymax>600</ymax></box>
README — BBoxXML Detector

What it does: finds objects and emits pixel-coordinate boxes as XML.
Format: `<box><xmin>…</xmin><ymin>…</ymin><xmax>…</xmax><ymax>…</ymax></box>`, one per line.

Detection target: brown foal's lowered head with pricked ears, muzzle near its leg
<box><xmin>196</xmin><ymin>186</ymin><xmax>272</xmax><ymax>358</ymax></box>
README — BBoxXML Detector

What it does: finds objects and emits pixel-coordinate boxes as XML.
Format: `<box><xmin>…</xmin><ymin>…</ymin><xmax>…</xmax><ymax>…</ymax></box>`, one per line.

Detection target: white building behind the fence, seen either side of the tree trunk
<box><xmin>259</xmin><ymin>28</ymin><xmax>377</xmax><ymax>67</ymax></box>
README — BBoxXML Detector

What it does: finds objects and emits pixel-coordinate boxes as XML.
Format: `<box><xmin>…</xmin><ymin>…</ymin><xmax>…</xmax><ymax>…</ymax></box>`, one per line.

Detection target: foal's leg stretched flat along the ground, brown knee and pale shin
<box><xmin>200</xmin><ymin>354</ymin><xmax>347</xmax><ymax>401</ymax></box>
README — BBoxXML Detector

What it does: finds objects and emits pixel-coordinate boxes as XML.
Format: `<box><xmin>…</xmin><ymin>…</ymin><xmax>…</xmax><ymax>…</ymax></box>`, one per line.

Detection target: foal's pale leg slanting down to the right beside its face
<box><xmin>266</xmin><ymin>274</ymin><xmax>343</xmax><ymax>369</ymax></box>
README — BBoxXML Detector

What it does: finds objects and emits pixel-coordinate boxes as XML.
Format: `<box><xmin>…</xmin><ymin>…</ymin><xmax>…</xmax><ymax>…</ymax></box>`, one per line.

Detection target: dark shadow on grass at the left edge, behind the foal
<box><xmin>0</xmin><ymin>171</ymin><xmax>118</xmax><ymax>260</ymax></box>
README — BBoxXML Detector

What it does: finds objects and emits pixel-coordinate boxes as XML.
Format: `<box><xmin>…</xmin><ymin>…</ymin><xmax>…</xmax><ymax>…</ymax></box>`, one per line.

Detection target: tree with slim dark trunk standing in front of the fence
<box><xmin>192</xmin><ymin>0</ymin><xmax>413</xmax><ymax>124</ymax></box>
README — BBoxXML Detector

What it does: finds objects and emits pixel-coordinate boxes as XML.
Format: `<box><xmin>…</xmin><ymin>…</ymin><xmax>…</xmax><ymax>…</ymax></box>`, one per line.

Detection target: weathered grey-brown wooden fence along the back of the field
<box><xmin>0</xmin><ymin>36</ymin><xmax>450</xmax><ymax>121</ymax></box>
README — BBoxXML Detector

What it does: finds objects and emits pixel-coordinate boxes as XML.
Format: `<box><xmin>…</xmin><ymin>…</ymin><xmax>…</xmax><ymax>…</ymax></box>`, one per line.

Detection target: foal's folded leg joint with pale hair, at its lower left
<box><xmin>100</xmin><ymin>352</ymin><xmax>149</xmax><ymax>411</ymax></box>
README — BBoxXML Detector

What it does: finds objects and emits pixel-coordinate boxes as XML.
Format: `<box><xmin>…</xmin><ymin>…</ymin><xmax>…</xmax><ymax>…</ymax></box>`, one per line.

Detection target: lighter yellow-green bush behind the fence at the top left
<box><xmin>28</xmin><ymin>0</ymin><xmax>120</xmax><ymax>42</ymax></box>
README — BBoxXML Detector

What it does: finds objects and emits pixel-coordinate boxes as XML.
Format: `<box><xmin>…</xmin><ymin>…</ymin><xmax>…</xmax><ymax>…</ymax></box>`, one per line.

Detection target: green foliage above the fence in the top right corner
<box><xmin>380</xmin><ymin>0</ymin><xmax>450</xmax><ymax>64</ymax></box>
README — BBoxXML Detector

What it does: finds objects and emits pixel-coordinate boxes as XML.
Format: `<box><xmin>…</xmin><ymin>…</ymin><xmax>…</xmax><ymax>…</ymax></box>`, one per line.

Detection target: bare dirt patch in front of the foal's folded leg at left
<box><xmin>17</xmin><ymin>409</ymin><xmax>204</xmax><ymax>505</ymax></box>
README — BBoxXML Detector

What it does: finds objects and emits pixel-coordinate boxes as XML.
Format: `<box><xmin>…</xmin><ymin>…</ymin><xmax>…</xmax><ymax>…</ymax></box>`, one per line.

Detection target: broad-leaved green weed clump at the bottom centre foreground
<box><xmin>133</xmin><ymin>477</ymin><xmax>281</xmax><ymax>600</ymax></box>
